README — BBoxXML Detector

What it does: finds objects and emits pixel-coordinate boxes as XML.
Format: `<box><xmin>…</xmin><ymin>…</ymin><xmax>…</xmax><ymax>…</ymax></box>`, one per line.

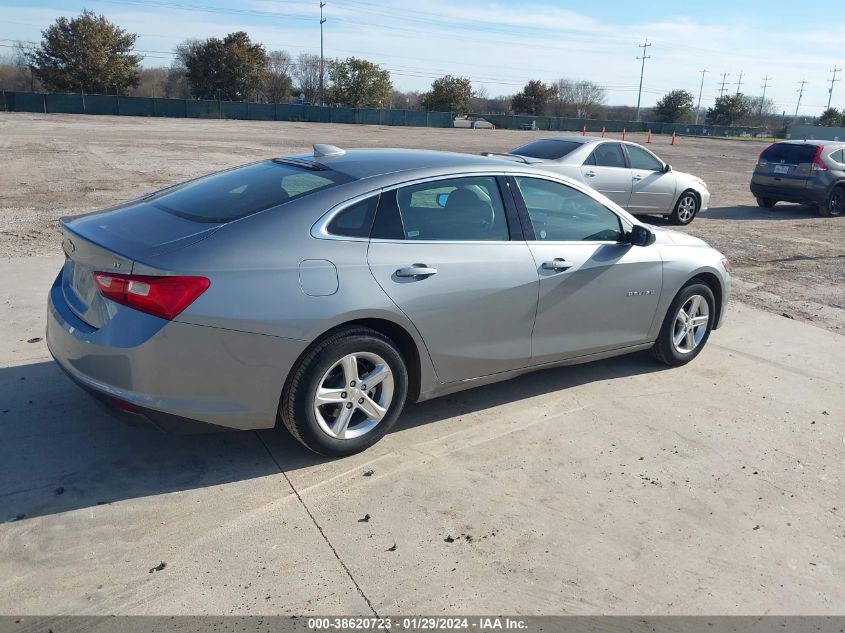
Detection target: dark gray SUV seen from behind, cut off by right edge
<box><xmin>751</xmin><ymin>141</ymin><xmax>845</xmax><ymax>217</ymax></box>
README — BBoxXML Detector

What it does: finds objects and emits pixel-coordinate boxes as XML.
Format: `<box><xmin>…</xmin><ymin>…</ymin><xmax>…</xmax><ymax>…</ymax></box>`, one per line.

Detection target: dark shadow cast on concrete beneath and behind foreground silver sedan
<box><xmin>0</xmin><ymin>353</ymin><xmax>665</xmax><ymax>521</ymax></box>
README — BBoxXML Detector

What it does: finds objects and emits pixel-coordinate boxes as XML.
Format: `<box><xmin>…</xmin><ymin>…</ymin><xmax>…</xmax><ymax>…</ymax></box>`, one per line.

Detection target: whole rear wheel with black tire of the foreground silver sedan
<box><xmin>279</xmin><ymin>327</ymin><xmax>408</xmax><ymax>457</ymax></box>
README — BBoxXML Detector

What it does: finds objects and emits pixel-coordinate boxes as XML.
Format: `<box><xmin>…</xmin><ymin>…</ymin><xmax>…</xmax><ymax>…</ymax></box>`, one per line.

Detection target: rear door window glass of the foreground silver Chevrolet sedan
<box><xmin>390</xmin><ymin>176</ymin><xmax>510</xmax><ymax>241</ymax></box>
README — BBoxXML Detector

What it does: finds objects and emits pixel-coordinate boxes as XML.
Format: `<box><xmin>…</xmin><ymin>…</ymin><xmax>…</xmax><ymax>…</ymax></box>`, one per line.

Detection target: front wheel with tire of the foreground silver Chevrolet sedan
<box><xmin>651</xmin><ymin>279</ymin><xmax>716</xmax><ymax>367</ymax></box>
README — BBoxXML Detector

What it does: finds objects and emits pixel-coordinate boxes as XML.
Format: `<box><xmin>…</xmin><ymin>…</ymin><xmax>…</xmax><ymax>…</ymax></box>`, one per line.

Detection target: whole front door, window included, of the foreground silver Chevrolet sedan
<box><xmin>515</xmin><ymin>176</ymin><xmax>662</xmax><ymax>364</ymax></box>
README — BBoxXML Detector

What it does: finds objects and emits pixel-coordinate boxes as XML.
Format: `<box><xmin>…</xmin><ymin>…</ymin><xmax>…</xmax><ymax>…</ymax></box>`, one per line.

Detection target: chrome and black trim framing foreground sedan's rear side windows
<box><xmin>311</xmin><ymin>170</ymin><xmax>525</xmax><ymax>244</ymax></box>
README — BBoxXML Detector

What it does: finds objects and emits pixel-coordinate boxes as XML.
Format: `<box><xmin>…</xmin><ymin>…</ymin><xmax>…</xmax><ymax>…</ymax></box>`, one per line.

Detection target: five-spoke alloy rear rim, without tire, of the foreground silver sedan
<box><xmin>314</xmin><ymin>352</ymin><xmax>394</xmax><ymax>440</ymax></box>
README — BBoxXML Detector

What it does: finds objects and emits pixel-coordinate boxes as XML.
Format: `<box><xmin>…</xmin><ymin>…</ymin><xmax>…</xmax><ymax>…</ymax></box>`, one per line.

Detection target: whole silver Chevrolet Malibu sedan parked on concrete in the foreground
<box><xmin>47</xmin><ymin>145</ymin><xmax>730</xmax><ymax>456</ymax></box>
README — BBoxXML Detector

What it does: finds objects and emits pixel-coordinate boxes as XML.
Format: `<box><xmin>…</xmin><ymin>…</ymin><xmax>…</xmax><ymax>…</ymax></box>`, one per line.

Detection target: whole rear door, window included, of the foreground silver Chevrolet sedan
<box><xmin>368</xmin><ymin>176</ymin><xmax>537</xmax><ymax>382</ymax></box>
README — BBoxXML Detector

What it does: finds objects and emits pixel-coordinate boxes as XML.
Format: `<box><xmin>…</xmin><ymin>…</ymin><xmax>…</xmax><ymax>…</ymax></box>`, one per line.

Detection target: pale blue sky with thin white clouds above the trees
<box><xmin>0</xmin><ymin>0</ymin><xmax>845</xmax><ymax>115</ymax></box>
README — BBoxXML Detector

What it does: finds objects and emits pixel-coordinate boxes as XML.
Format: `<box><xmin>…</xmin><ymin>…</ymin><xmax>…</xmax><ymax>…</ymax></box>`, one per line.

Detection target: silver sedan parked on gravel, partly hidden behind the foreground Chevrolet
<box><xmin>498</xmin><ymin>136</ymin><xmax>710</xmax><ymax>225</ymax></box>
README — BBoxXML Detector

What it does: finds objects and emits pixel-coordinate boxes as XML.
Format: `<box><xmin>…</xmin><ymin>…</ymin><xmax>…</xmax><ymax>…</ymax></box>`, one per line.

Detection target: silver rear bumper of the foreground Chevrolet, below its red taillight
<box><xmin>47</xmin><ymin>275</ymin><xmax>307</xmax><ymax>432</ymax></box>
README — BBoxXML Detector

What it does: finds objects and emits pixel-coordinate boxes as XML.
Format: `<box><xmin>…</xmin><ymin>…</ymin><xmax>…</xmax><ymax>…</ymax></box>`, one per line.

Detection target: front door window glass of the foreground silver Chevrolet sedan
<box><xmin>516</xmin><ymin>176</ymin><xmax>622</xmax><ymax>242</ymax></box>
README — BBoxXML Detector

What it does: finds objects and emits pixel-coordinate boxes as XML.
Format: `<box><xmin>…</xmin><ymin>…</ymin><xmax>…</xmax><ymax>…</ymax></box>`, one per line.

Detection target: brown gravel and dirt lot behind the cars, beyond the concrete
<box><xmin>0</xmin><ymin>113</ymin><xmax>845</xmax><ymax>333</ymax></box>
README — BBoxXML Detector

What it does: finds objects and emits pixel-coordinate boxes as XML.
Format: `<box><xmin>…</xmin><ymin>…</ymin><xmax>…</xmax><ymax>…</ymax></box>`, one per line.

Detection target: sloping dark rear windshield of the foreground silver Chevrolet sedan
<box><xmin>147</xmin><ymin>161</ymin><xmax>352</xmax><ymax>222</ymax></box>
